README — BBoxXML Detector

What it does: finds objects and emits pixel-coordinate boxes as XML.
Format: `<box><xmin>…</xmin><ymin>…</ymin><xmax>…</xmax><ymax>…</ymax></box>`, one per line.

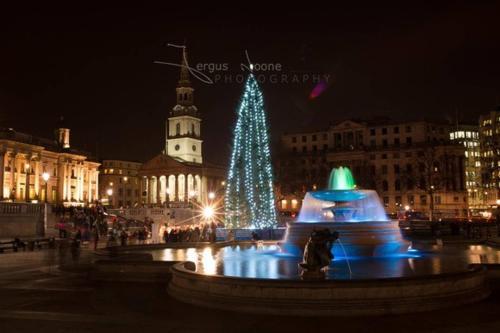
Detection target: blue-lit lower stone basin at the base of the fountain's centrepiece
<box><xmin>281</xmin><ymin>221</ymin><xmax>410</xmax><ymax>257</ymax></box>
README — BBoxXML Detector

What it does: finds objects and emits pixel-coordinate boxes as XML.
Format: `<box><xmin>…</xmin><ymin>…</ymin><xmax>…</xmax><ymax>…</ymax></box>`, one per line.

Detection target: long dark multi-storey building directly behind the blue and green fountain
<box><xmin>277</xmin><ymin>120</ymin><xmax>468</xmax><ymax>217</ymax></box>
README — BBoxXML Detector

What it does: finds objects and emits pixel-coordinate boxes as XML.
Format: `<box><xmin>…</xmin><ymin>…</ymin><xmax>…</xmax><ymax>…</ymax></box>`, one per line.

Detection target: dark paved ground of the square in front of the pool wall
<box><xmin>0</xmin><ymin>243</ymin><xmax>500</xmax><ymax>332</ymax></box>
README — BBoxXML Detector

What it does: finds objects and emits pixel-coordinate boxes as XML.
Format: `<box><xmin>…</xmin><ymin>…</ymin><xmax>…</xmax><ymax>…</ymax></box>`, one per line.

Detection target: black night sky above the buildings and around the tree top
<box><xmin>0</xmin><ymin>1</ymin><xmax>500</xmax><ymax>162</ymax></box>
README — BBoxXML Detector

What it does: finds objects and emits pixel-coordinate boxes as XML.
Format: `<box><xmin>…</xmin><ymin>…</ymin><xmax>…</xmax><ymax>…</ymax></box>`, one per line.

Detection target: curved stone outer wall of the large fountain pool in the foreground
<box><xmin>168</xmin><ymin>263</ymin><xmax>489</xmax><ymax>316</ymax></box>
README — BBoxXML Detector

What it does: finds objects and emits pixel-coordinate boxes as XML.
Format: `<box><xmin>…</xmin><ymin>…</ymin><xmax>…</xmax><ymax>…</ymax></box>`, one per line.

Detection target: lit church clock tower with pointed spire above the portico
<box><xmin>165</xmin><ymin>48</ymin><xmax>203</xmax><ymax>164</ymax></box>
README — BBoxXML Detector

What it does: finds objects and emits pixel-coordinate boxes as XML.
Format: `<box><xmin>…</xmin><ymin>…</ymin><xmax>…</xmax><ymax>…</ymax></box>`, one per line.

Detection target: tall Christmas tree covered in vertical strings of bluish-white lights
<box><xmin>225</xmin><ymin>73</ymin><xmax>277</xmax><ymax>228</ymax></box>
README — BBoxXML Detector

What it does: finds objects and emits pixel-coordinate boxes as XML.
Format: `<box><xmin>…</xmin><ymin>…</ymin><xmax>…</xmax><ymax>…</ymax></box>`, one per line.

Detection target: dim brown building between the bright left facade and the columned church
<box><xmin>99</xmin><ymin>160</ymin><xmax>142</xmax><ymax>207</ymax></box>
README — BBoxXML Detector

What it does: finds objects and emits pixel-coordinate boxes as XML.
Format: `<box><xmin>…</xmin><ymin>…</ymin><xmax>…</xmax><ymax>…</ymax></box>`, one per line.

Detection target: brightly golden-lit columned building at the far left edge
<box><xmin>0</xmin><ymin>128</ymin><xmax>99</xmax><ymax>206</ymax></box>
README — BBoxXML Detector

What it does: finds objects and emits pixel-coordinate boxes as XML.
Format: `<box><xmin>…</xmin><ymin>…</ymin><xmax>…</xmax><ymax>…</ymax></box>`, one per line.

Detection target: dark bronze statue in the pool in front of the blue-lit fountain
<box><xmin>299</xmin><ymin>228</ymin><xmax>339</xmax><ymax>275</ymax></box>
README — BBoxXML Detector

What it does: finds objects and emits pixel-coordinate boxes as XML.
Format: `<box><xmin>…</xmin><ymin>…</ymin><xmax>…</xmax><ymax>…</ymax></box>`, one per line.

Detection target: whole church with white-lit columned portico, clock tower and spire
<box><xmin>139</xmin><ymin>49</ymin><xmax>226</xmax><ymax>206</ymax></box>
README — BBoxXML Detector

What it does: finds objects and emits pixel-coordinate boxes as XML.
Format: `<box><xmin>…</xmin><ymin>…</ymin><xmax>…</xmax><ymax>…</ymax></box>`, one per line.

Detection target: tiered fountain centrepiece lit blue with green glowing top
<box><xmin>283</xmin><ymin>167</ymin><xmax>410</xmax><ymax>257</ymax></box>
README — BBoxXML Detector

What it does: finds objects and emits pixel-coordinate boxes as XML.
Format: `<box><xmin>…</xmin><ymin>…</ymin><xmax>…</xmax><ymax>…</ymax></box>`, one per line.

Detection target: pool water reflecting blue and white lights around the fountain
<box><xmin>151</xmin><ymin>243</ymin><xmax>500</xmax><ymax>280</ymax></box>
